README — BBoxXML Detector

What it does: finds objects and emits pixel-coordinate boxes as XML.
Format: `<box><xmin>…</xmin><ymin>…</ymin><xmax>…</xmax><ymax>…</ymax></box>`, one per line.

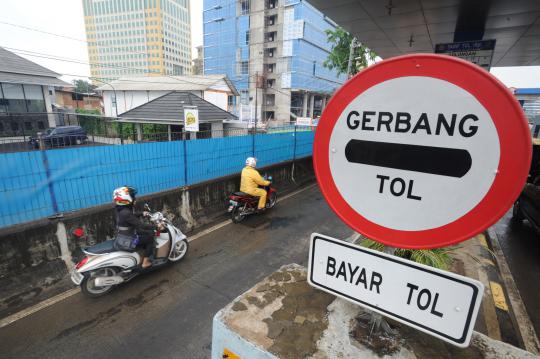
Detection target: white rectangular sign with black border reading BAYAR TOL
<box><xmin>308</xmin><ymin>233</ymin><xmax>484</xmax><ymax>347</ymax></box>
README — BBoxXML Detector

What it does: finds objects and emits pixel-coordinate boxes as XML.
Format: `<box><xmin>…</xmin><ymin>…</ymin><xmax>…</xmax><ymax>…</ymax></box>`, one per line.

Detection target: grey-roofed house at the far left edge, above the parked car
<box><xmin>0</xmin><ymin>47</ymin><xmax>70</xmax><ymax>136</ymax></box>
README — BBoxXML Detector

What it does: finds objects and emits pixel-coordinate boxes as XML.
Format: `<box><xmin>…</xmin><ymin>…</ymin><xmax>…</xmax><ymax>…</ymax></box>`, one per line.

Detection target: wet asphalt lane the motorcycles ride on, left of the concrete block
<box><xmin>0</xmin><ymin>186</ymin><xmax>352</xmax><ymax>359</ymax></box>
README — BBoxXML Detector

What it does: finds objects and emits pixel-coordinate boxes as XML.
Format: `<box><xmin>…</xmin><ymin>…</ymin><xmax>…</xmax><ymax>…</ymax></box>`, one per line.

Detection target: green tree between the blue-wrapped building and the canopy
<box><xmin>323</xmin><ymin>27</ymin><xmax>377</xmax><ymax>75</ymax></box>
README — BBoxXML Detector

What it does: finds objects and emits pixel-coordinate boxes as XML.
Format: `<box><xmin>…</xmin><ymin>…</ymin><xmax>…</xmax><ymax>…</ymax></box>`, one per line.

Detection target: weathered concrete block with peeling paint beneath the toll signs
<box><xmin>212</xmin><ymin>264</ymin><xmax>537</xmax><ymax>359</ymax></box>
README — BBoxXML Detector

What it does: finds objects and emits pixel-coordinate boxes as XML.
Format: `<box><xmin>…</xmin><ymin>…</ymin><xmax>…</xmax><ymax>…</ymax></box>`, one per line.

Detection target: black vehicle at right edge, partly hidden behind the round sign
<box><xmin>512</xmin><ymin>142</ymin><xmax>540</xmax><ymax>233</ymax></box>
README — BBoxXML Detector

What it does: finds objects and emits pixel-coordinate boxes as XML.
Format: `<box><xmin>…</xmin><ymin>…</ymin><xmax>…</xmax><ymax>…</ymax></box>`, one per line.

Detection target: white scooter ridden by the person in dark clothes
<box><xmin>71</xmin><ymin>205</ymin><xmax>188</xmax><ymax>297</ymax></box>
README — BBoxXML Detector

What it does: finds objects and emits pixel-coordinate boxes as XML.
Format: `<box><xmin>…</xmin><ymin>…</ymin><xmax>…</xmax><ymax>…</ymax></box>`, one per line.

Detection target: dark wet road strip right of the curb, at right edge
<box><xmin>495</xmin><ymin>211</ymin><xmax>540</xmax><ymax>334</ymax></box>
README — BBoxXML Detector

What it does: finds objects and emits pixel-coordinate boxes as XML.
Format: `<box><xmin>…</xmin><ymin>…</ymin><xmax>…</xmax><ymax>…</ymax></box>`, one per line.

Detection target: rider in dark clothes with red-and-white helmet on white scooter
<box><xmin>113</xmin><ymin>186</ymin><xmax>160</xmax><ymax>268</ymax></box>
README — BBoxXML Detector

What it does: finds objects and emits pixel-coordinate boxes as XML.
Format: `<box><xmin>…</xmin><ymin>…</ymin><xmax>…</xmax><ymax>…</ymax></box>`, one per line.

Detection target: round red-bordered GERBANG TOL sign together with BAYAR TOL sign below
<box><xmin>309</xmin><ymin>54</ymin><xmax>532</xmax><ymax>347</ymax></box>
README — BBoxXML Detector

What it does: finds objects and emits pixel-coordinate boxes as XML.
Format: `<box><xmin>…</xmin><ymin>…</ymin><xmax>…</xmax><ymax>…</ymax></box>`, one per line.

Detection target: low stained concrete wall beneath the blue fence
<box><xmin>0</xmin><ymin>157</ymin><xmax>314</xmax><ymax>318</ymax></box>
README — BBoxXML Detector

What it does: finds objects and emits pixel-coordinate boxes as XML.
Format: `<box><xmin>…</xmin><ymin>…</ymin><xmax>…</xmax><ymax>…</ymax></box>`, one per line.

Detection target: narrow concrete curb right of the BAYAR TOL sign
<box><xmin>486</xmin><ymin>227</ymin><xmax>540</xmax><ymax>355</ymax></box>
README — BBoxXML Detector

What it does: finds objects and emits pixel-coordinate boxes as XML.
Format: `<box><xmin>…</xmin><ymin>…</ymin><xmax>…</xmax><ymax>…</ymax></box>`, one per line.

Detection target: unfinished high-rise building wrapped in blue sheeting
<box><xmin>203</xmin><ymin>0</ymin><xmax>345</xmax><ymax>125</ymax></box>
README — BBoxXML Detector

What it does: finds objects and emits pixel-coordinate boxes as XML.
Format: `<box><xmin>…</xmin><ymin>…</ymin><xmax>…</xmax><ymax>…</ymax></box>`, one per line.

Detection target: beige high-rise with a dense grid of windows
<box><xmin>83</xmin><ymin>0</ymin><xmax>191</xmax><ymax>79</ymax></box>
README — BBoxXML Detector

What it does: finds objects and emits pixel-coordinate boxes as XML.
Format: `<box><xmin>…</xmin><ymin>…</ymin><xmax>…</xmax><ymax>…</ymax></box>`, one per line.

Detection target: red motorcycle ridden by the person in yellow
<box><xmin>228</xmin><ymin>175</ymin><xmax>277</xmax><ymax>223</ymax></box>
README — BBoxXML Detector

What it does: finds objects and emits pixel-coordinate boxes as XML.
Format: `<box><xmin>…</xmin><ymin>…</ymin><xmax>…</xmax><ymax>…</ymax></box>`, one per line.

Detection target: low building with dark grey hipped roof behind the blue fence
<box><xmin>116</xmin><ymin>91</ymin><xmax>238</xmax><ymax>141</ymax></box>
